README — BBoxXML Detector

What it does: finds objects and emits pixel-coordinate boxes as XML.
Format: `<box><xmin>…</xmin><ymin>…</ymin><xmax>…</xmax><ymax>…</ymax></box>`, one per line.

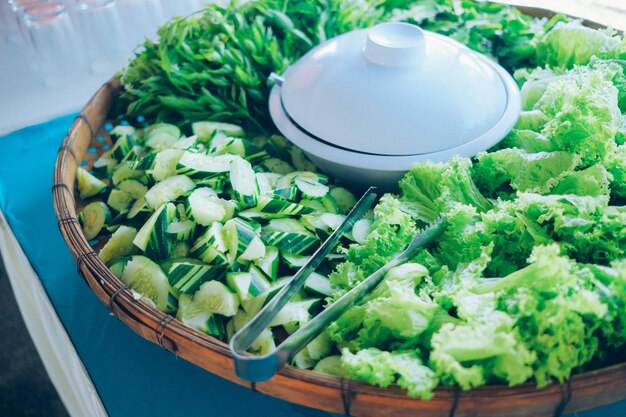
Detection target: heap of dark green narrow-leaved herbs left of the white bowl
<box><xmin>119</xmin><ymin>0</ymin><xmax>382</xmax><ymax>131</ymax></box>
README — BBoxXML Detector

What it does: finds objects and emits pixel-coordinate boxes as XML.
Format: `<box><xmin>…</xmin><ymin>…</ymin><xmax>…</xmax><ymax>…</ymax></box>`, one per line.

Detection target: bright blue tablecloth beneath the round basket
<box><xmin>0</xmin><ymin>115</ymin><xmax>626</xmax><ymax>417</ymax></box>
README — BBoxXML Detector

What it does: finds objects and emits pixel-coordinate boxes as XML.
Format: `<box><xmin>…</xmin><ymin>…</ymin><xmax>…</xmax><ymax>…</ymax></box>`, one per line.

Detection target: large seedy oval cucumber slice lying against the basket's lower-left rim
<box><xmin>122</xmin><ymin>255</ymin><xmax>169</xmax><ymax>312</ymax></box>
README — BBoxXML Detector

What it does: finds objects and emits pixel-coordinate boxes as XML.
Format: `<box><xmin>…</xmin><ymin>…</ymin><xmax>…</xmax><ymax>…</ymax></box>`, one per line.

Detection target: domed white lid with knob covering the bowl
<box><xmin>275</xmin><ymin>22</ymin><xmax>520</xmax><ymax>156</ymax></box>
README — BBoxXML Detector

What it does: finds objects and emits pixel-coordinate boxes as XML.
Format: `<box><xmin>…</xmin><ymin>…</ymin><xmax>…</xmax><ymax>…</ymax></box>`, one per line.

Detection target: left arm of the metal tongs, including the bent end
<box><xmin>230</xmin><ymin>187</ymin><xmax>376</xmax><ymax>382</ymax></box>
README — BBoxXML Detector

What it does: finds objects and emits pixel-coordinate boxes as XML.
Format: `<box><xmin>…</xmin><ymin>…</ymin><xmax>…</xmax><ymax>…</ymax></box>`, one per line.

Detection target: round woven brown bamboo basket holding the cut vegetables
<box><xmin>52</xmin><ymin>4</ymin><xmax>626</xmax><ymax>417</ymax></box>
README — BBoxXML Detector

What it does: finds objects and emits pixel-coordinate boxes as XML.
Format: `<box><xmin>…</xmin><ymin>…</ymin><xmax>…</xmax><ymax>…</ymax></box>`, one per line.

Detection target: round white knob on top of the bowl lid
<box><xmin>363</xmin><ymin>22</ymin><xmax>424</xmax><ymax>67</ymax></box>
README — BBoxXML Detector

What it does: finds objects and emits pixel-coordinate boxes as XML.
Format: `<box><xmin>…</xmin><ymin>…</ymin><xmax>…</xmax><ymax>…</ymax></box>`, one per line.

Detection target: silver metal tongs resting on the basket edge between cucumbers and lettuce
<box><xmin>230</xmin><ymin>187</ymin><xmax>445</xmax><ymax>382</ymax></box>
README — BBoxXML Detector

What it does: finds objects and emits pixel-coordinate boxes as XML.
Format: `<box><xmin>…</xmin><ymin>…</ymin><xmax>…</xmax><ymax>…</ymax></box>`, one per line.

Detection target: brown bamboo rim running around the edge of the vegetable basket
<box><xmin>52</xmin><ymin>7</ymin><xmax>626</xmax><ymax>416</ymax></box>
